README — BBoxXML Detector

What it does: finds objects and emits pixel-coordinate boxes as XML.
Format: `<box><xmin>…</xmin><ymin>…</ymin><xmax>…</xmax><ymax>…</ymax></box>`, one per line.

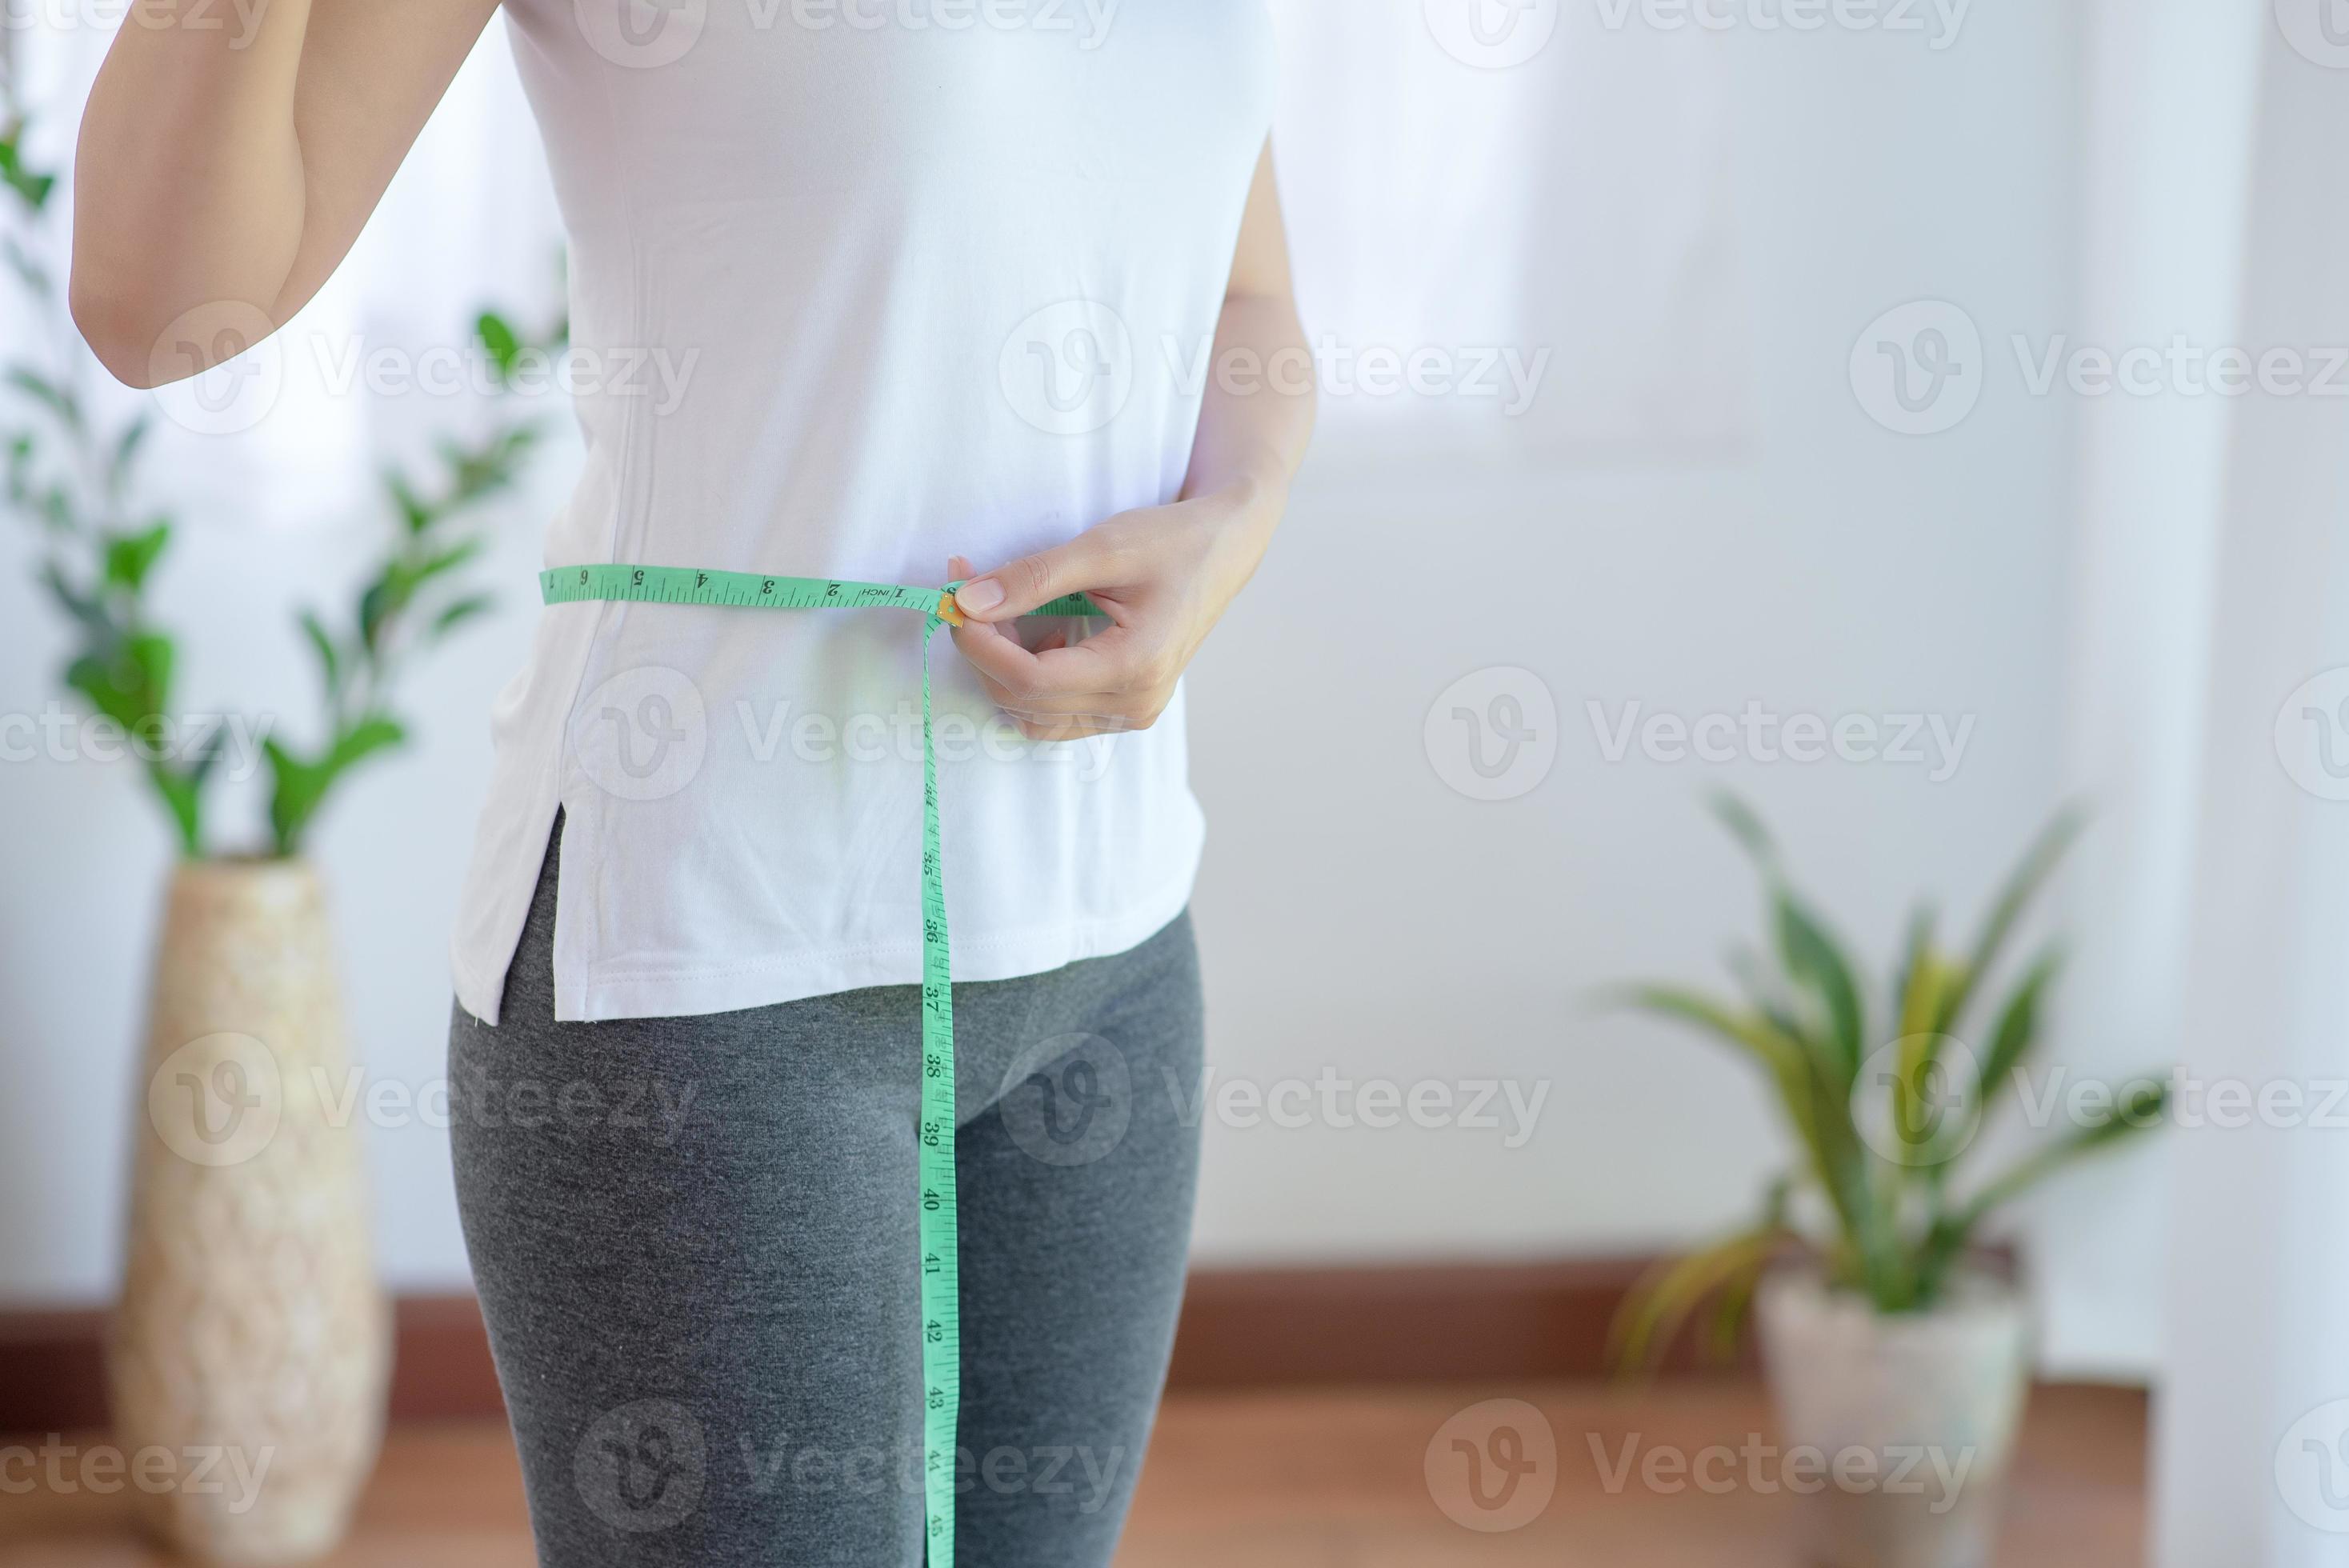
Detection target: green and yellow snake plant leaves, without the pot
<box><xmin>1614</xmin><ymin>796</ymin><xmax>2168</xmax><ymax>1369</ymax></box>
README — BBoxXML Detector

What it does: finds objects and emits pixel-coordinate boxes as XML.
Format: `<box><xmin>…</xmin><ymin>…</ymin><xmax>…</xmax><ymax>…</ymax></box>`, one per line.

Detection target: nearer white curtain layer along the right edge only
<box><xmin>2156</xmin><ymin>0</ymin><xmax>2349</xmax><ymax>1568</ymax></box>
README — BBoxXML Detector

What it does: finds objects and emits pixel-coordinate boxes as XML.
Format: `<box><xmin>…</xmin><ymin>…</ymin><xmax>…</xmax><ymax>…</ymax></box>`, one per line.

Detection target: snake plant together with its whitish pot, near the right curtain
<box><xmin>1614</xmin><ymin>798</ymin><xmax>2168</xmax><ymax>1568</ymax></box>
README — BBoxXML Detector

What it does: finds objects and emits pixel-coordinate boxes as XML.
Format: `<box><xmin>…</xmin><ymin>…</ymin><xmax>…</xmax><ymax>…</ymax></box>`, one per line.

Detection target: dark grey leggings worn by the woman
<box><xmin>449</xmin><ymin>826</ymin><xmax>1200</xmax><ymax>1568</ymax></box>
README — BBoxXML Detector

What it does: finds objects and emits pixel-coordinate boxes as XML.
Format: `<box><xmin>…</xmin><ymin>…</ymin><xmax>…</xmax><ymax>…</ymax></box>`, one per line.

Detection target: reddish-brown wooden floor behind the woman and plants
<box><xmin>0</xmin><ymin>1382</ymin><xmax>2145</xmax><ymax>1568</ymax></box>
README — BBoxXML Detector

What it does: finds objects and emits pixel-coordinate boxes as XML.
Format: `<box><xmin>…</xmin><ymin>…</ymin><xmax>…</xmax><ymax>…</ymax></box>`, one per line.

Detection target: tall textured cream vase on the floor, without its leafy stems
<box><xmin>108</xmin><ymin>862</ymin><xmax>390</xmax><ymax>1563</ymax></box>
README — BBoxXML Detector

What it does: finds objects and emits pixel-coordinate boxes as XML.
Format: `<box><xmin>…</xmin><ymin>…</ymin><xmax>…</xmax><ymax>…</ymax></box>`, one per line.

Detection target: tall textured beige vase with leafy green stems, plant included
<box><xmin>0</xmin><ymin>88</ymin><xmax>559</xmax><ymax>1563</ymax></box>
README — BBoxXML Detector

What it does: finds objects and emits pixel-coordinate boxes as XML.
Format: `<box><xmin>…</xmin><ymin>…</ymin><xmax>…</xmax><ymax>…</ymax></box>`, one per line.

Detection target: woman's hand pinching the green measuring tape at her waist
<box><xmin>949</xmin><ymin>483</ymin><xmax>1287</xmax><ymax>739</ymax></box>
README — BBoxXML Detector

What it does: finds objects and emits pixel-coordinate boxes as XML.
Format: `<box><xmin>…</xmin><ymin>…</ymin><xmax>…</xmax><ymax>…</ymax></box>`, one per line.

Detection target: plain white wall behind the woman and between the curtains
<box><xmin>0</xmin><ymin>5</ymin><xmax>2132</xmax><ymax>1352</ymax></box>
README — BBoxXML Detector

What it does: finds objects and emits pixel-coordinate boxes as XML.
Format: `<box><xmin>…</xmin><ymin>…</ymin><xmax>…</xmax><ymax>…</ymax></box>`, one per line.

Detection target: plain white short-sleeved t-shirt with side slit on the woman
<box><xmin>454</xmin><ymin>0</ymin><xmax>1271</xmax><ymax>1021</ymax></box>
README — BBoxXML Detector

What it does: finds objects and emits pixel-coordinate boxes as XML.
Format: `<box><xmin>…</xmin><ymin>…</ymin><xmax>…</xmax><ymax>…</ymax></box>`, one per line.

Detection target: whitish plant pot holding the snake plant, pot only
<box><xmin>1757</xmin><ymin>1270</ymin><xmax>2032</xmax><ymax>1568</ymax></box>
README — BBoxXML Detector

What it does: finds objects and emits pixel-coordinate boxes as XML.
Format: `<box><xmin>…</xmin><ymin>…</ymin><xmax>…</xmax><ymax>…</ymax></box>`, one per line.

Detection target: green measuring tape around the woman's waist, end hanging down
<box><xmin>538</xmin><ymin>566</ymin><xmax>1102</xmax><ymax>1568</ymax></box>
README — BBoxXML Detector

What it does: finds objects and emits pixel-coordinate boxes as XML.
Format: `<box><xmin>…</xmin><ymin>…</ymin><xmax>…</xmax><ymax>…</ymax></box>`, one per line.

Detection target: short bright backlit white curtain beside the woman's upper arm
<box><xmin>1271</xmin><ymin>0</ymin><xmax>1750</xmax><ymax>462</ymax></box>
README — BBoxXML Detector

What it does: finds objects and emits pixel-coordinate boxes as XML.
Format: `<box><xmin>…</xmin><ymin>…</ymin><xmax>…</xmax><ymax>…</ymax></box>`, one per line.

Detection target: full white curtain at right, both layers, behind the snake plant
<box><xmin>2067</xmin><ymin>0</ymin><xmax>2349</xmax><ymax>1568</ymax></box>
